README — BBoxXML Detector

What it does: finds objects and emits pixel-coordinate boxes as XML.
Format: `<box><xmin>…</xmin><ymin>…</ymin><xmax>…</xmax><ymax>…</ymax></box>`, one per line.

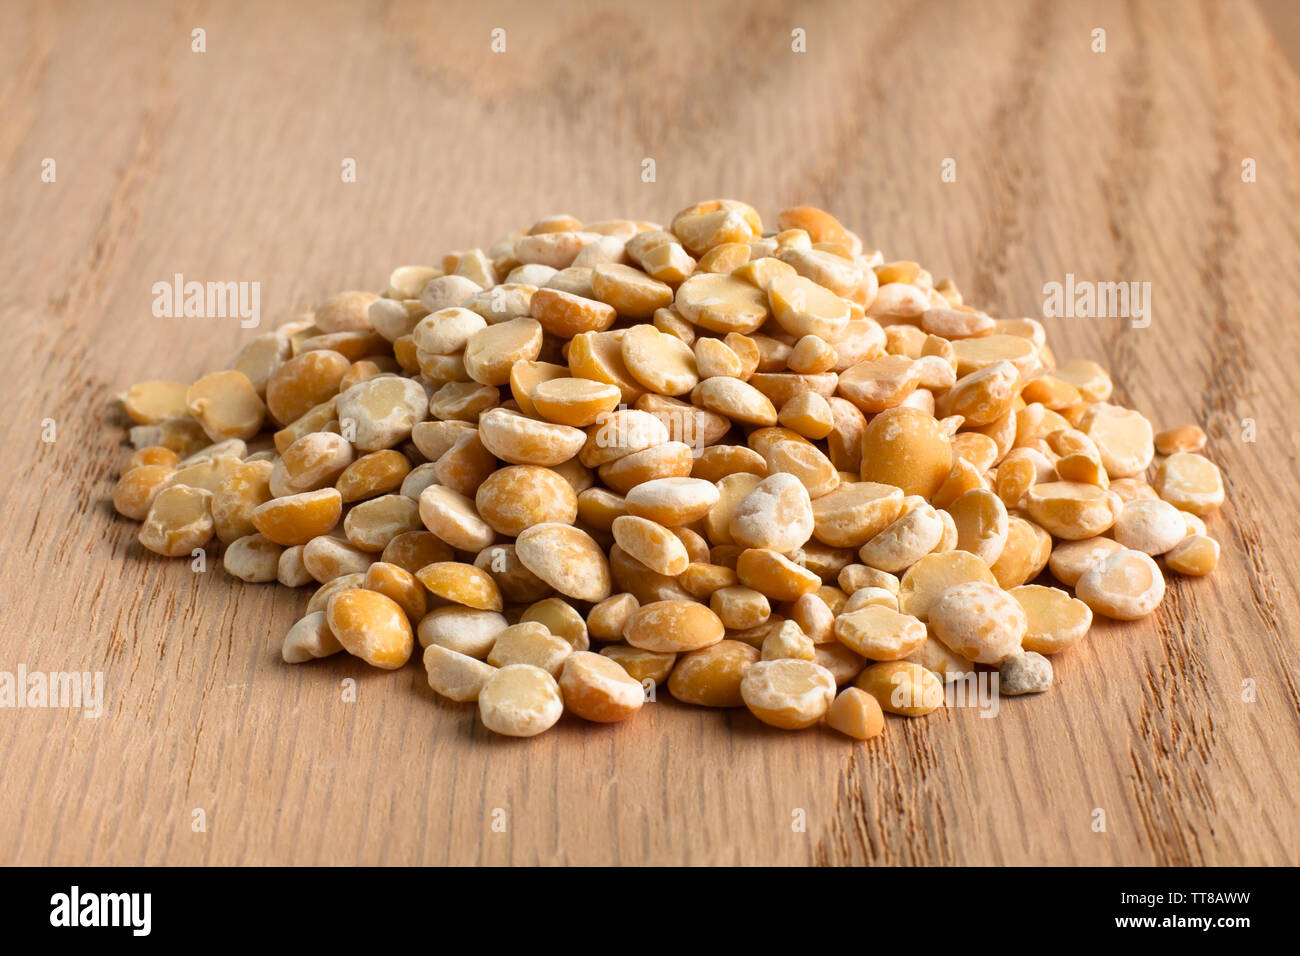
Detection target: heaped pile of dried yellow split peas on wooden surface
<box><xmin>113</xmin><ymin>199</ymin><xmax>1223</xmax><ymax>739</ymax></box>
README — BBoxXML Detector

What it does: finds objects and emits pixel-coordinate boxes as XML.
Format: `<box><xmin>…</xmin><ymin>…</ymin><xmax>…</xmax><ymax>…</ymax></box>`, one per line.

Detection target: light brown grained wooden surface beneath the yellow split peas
<box><xmin>0</xmin><ymin>0</ymin><xmax>1300</xmax><ymax>865</ymax></box>
